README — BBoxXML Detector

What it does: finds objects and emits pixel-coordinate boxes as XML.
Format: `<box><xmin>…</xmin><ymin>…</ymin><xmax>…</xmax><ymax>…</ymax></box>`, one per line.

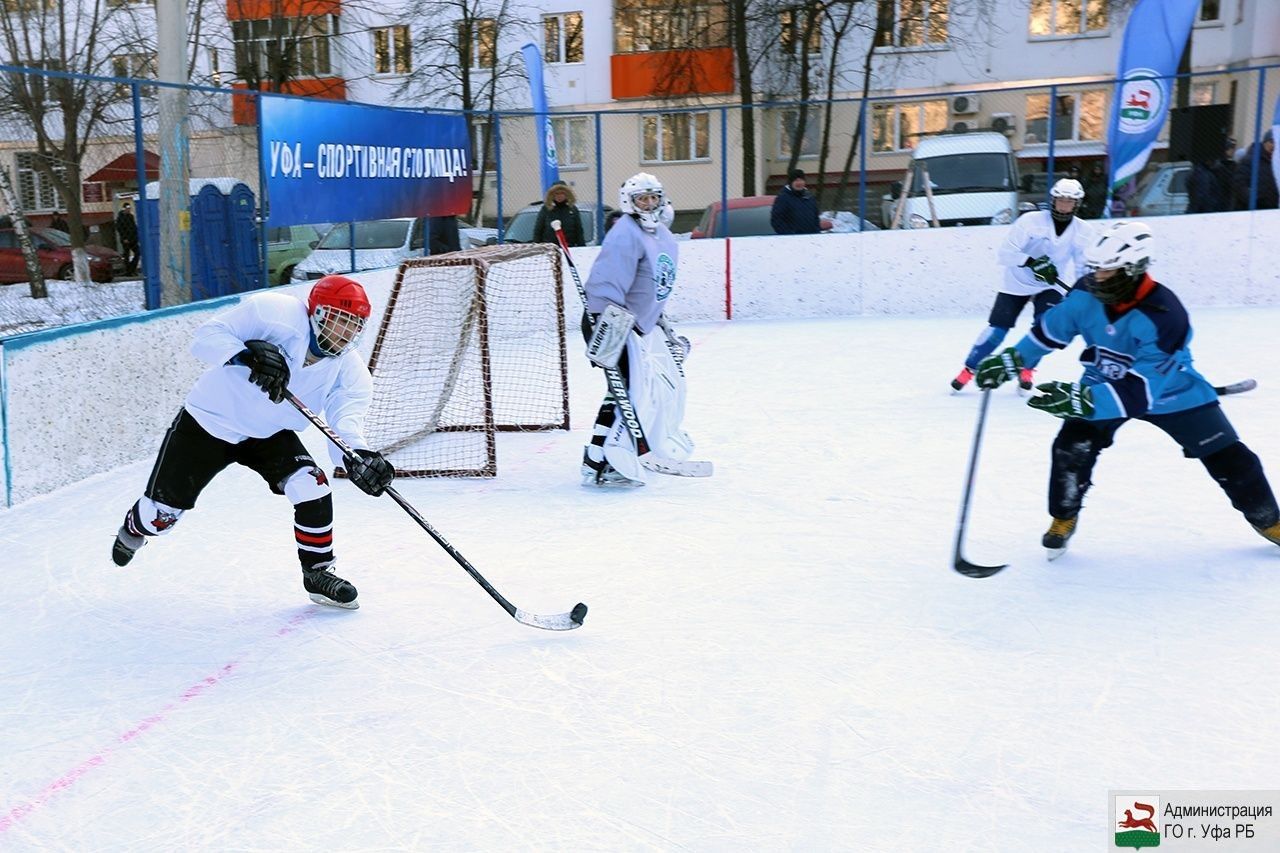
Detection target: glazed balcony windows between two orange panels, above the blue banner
<box><xmin>232</xmin><ymin>15</ymin><xmax>339</xmax><ymax>79</ymax></box>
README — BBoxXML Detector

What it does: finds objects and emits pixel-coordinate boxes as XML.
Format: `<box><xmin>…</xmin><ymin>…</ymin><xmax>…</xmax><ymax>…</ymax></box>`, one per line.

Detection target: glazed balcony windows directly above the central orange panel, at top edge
<box><xmin>613</xmin><ymin>0</ymin><xmax>728</xmax><ymax>54</ymax></box>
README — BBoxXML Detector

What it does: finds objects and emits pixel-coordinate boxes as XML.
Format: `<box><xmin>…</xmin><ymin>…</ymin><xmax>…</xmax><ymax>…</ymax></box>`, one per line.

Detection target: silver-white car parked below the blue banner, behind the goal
<box><xmin>291</xmin><ymin>216</ymin><xmax>426</xmax><ymax>282</ymax></box>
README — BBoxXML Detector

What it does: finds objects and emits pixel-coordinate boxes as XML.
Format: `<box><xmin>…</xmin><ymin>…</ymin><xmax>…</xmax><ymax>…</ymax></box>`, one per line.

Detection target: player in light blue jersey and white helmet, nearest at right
<box><xmin>977</xmin><ymin>216</ymin><xmax>1280</xmax><ymax>560</ymax></box>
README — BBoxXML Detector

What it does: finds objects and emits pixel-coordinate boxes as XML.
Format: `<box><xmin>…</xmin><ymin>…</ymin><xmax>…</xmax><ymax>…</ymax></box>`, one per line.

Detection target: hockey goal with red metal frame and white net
<box><xmin>355</xmin><ymin>243</ymin><xmax>568</xmax><ymax>476</ymax></box>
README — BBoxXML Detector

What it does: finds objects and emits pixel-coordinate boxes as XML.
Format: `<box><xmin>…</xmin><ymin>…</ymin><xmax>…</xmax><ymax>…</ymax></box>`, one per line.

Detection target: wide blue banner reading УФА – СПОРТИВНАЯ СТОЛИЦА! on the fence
<box><xmin>259</xmin><ymin>93</ymin><xmax>471</xmax><ymax>225</ymax></box>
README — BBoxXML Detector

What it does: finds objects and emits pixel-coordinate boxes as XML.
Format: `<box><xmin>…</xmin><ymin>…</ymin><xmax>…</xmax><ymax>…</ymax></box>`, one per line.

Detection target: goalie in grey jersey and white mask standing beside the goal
<box><xmin>581</xmin><ymin>172</ymin><xmax>692</xmax><ymax>485</ymax></box>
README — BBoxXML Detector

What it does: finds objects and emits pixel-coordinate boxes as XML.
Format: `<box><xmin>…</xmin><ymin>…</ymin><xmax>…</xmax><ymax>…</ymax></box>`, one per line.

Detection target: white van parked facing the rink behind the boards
<box><xmin>881</xmin><ymin>133</ymin><xmax>1034</xmax><ymax>228</ymax></box>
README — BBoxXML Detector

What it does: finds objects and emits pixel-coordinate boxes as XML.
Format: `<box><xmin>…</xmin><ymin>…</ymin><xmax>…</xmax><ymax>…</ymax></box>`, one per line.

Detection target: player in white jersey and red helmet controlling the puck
<box><xmin>111</xmin><ymin>275</ymin><xmax>396</xmax><ymax>610</ymax></box>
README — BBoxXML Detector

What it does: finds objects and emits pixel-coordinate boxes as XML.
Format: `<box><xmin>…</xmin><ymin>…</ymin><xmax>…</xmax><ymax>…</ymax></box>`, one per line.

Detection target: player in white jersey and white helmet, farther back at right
<box><xmin>951</xmin><ymin>178</ymin><xmax>1096</xmax><ymax>391</ymax></box>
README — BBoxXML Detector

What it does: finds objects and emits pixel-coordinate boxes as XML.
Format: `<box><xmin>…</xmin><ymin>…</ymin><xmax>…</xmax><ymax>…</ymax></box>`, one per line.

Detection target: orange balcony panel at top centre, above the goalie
<box><xmin>609</xmin><ymin>47</ymin><xmax>733</xmax><ymax>100</ymax></box>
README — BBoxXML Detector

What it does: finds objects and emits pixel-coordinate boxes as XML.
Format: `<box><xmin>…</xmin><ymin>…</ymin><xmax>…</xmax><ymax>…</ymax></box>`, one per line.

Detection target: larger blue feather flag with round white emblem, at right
<box><xmin>1107</xmin><ymin>0</ymin><xmax>1201</xmax><ymax>190</ymax></box>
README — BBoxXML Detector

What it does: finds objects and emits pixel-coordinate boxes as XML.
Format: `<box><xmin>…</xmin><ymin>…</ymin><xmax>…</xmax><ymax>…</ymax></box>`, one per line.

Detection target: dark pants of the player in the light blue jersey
<box><xmin>1048</xmin><ymin>402</ymin><xmax>1280</xmax><ymax>528</ymax></box>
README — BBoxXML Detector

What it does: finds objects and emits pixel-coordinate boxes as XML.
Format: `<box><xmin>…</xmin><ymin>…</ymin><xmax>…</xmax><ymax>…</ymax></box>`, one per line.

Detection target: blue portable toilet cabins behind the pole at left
<box><xmin>142</xmin><ymin>178</ymin><xmax>262</xmax><ymax>301</ymax></box>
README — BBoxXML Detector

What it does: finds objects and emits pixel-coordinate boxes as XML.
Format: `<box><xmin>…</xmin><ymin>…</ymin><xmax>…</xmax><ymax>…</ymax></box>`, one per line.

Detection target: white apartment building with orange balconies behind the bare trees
<box><xmin>5</xmin><ymin>0</ymin><xmax>1280</xmax><ymax>225</ymax></box>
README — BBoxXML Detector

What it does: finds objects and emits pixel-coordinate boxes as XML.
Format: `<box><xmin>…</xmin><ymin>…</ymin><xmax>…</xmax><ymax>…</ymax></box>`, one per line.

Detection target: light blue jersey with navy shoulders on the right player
<box><xmin>1016</xmin><ymin>275</ymin><xmax>1217</xmax><ymax>420</ymax></box>
